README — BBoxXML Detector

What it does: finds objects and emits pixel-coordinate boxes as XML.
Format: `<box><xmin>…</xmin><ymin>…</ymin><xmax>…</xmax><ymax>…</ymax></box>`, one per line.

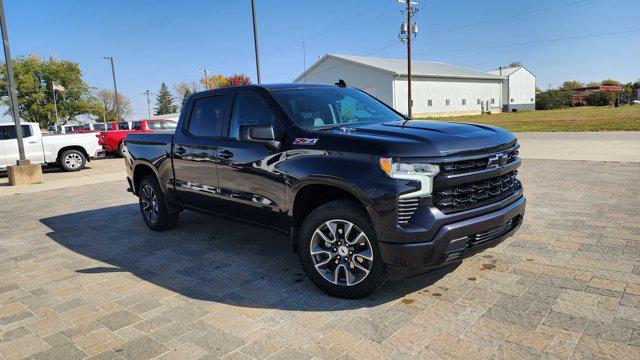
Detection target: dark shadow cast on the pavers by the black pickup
<box><xmin>40</xmin><ymin>204</ymin><xmax>455</xmax><ymax>311</ymax></box>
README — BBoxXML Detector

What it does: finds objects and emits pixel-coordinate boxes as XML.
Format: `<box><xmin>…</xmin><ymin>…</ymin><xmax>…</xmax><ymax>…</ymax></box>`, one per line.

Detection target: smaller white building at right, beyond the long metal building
<box><xmin>489</xmin><ymin>66</ymin><xmax>536</xmax><ymax>112</ymax></box>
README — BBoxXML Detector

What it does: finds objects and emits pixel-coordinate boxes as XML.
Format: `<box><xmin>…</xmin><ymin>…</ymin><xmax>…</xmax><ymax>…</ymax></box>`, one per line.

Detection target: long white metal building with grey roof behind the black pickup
<box><xmin>294</xmin><ymin>54</ymin><xmax>535</xmax><ymax>117</ymax></box>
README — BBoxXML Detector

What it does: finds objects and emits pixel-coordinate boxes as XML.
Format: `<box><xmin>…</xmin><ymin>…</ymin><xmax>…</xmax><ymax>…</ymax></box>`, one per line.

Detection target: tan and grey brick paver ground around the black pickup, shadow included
<box><xmin>0</xmin><ymin>160</ymin><xmax>640</xmax><ymax>359</ymax></box>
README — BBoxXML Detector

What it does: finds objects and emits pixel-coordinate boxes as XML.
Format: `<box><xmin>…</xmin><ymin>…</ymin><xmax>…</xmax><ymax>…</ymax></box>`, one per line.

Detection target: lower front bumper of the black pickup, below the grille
<box><xmin>378</xmin><ymin>197</ymin><xmax>526</xmax><ymax>268</ymax></box>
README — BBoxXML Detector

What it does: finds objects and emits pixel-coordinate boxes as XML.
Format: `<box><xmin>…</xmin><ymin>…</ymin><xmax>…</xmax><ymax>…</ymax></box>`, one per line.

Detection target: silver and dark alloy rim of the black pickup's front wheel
<box><xmin>309</xmin><ymin>219</ymin><xmax>373</xmax><ymax>286</ymax></box>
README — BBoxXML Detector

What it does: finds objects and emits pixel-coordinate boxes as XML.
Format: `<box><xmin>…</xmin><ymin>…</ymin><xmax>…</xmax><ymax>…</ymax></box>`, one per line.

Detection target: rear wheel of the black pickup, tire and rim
<box><xmin>138</xmin><ymin>175</ymin><xmax>179</xmax><ymax>231</ymax></box>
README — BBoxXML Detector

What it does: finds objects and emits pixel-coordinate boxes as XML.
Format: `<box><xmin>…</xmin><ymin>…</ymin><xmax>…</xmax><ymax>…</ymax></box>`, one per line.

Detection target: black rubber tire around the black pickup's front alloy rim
<box><xmin>298</xmin><ymin>200</ymin><xmax>386</xmax><ymax>299</ymax></box>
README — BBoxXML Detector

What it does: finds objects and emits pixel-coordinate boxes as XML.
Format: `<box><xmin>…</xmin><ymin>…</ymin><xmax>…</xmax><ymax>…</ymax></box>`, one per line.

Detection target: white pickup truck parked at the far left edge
<box><xmin>0</xmin><ymin>122</ymin><xmax>105</xmax><ymax>171</ymax></box>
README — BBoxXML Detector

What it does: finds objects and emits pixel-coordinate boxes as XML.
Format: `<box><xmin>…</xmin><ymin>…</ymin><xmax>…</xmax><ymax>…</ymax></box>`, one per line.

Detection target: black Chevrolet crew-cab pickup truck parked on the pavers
<box><xmin>125</xmin><ymin>84</ymin><xmax>525</xmax><ymax>298</ymax></box>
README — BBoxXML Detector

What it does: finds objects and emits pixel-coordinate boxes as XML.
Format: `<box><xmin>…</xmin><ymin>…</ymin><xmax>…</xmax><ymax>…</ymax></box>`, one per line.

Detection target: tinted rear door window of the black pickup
<box><xmin>188</xmin><ymin>96</ymin><xmax>225</xmax><ymax>137</ymax></box>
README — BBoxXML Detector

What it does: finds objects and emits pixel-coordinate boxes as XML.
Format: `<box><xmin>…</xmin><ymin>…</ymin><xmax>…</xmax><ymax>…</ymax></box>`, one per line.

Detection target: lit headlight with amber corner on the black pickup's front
<box><xmin>380</xmin><ymin>158</ymin><xmax>440</xmax><ymax>198</ymax></box>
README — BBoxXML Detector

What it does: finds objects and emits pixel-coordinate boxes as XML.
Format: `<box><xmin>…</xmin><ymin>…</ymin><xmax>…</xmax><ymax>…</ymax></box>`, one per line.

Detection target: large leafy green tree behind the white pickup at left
<box><xmin>0</xmin><ymin>55</ymin><xmax>100</xmax><ymax>127</ymax></box>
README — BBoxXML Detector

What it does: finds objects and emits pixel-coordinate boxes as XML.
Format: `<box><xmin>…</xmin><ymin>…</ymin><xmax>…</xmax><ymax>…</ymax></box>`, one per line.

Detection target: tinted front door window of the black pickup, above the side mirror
<box><xmin>229</xmin><ymin>94</ymin><xmax>276</xmax><ymax>139</ymax></box>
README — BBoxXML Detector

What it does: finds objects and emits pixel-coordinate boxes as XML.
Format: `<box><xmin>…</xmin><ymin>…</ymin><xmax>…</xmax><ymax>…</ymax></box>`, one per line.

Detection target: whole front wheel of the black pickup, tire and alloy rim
<box><xmin>298</xmin><ymin>200</ymin><xmax>385</xmax><ymax>299</ymax></box>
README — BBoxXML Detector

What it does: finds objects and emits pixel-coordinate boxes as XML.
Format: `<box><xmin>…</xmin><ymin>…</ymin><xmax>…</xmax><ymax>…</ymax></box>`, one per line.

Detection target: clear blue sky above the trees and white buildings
<box><xmin>4</xmin><ymin>0</ymin><xmax>640</xmax><ymax>118</ymax></box>
